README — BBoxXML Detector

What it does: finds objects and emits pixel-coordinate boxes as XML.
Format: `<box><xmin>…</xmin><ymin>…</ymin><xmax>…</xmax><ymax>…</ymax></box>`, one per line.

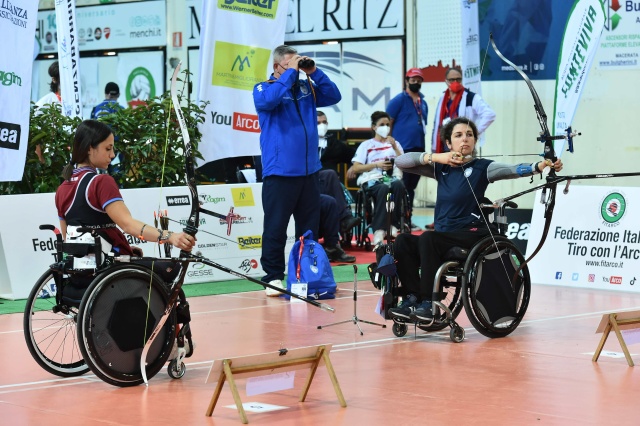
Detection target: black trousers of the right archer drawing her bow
<box><xmin>394</xmin><ymin>227</ymin><xmax>490</xmax><ymax>300</ymax></box>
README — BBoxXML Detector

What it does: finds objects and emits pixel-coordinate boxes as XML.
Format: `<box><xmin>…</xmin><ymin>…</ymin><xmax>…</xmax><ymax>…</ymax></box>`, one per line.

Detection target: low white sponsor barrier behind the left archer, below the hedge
<box><xmin>0</xmin><ymin>184</ymin><xmax>295</xmax><ymax>299</ymax></box>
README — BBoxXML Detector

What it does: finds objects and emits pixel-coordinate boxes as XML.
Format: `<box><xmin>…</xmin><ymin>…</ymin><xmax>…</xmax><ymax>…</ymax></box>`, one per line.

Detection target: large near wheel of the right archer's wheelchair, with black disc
<box><xmin>462</xmin><ymin>236</ymin><xmax>531</xmax><ymax>338</ymax></box>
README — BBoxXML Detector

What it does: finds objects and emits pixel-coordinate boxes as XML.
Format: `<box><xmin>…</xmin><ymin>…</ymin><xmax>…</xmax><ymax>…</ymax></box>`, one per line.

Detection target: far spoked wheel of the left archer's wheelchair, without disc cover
<box><xmin>23</xmin><ymin>271</ymin><xmax>89</xmax><ymax>377</ymax></box>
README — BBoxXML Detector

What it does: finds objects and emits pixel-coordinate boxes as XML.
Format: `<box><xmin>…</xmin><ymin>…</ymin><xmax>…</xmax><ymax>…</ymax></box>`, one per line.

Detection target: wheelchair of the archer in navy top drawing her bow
<box><xmin>384</xmin><ymin>201</ymin><xmax>531</xmax><ymax>343</ymax></box>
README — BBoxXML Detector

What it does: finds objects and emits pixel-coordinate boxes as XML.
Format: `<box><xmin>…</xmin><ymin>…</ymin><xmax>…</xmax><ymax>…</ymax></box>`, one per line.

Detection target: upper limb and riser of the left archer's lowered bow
<box><xmin>171</xmin><ymin>62</ymin><xmax>200</xmax><ymax>250</ymax></box>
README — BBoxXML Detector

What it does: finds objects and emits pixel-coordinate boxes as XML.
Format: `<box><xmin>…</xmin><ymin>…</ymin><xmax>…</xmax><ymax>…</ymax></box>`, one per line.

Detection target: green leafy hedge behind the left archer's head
<box><xmin>0</xmin><ymin>71</ymin><xmax>206</xmax><ymax>195</ymax></box>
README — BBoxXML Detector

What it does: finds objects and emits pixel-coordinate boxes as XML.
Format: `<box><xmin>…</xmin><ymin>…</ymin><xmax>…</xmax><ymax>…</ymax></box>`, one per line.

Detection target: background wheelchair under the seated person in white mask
<box><xmin>354</xmin><ymin>176</ymin><xmax>411</xmax><ymax>250</ymax></box>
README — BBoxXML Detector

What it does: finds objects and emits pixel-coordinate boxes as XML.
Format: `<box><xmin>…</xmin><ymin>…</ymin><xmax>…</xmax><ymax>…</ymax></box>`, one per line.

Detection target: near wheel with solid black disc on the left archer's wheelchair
<box><xmin>78</xmin><ymin>264</ymin><xmax>176</xmax><ymax>387</ymax></box>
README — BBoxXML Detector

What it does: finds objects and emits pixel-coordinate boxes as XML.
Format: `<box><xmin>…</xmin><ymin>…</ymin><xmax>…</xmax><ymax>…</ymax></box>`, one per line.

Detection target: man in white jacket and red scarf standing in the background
<box><xmin>431</xmin><ymin>68</ymin><xmax>496</xmax><ymax>153</ymax></box>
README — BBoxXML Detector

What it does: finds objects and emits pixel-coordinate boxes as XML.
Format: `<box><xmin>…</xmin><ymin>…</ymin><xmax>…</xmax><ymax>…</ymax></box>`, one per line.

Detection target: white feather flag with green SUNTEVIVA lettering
<box><xmin>552</xmin><ymin>0</ymin><xmax>606</xmax><ymax>156</ymax></box>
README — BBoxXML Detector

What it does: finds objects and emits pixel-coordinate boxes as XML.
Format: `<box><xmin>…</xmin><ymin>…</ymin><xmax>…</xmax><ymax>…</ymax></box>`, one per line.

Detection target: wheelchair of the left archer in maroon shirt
<box><xmin>24</xmin><ymin>225</ymin><xmax>193</xmax><ymax>386</ymax></box>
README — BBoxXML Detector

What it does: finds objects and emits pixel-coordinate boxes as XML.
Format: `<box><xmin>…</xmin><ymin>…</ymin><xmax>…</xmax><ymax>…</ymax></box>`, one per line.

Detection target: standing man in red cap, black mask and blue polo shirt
<box><xmin>386</xmin><ymin>68</ymin><xmax>429</xmax><ymax>230</ymax></box>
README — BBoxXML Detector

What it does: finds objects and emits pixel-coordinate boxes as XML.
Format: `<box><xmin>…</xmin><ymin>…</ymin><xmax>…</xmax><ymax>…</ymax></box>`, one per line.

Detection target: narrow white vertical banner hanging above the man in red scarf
<box><xmin>460</xmin><ymin>0</ymin><xmax>482</xmax><ymax>95</ymax></box>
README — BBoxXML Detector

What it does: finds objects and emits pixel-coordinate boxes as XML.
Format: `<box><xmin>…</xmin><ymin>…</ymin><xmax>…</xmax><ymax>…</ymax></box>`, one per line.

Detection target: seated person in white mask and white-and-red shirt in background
<box><xmin>351</xmin><ymin>111</ymin><xmax>406</xmax><ymax>246</ymax></box>
